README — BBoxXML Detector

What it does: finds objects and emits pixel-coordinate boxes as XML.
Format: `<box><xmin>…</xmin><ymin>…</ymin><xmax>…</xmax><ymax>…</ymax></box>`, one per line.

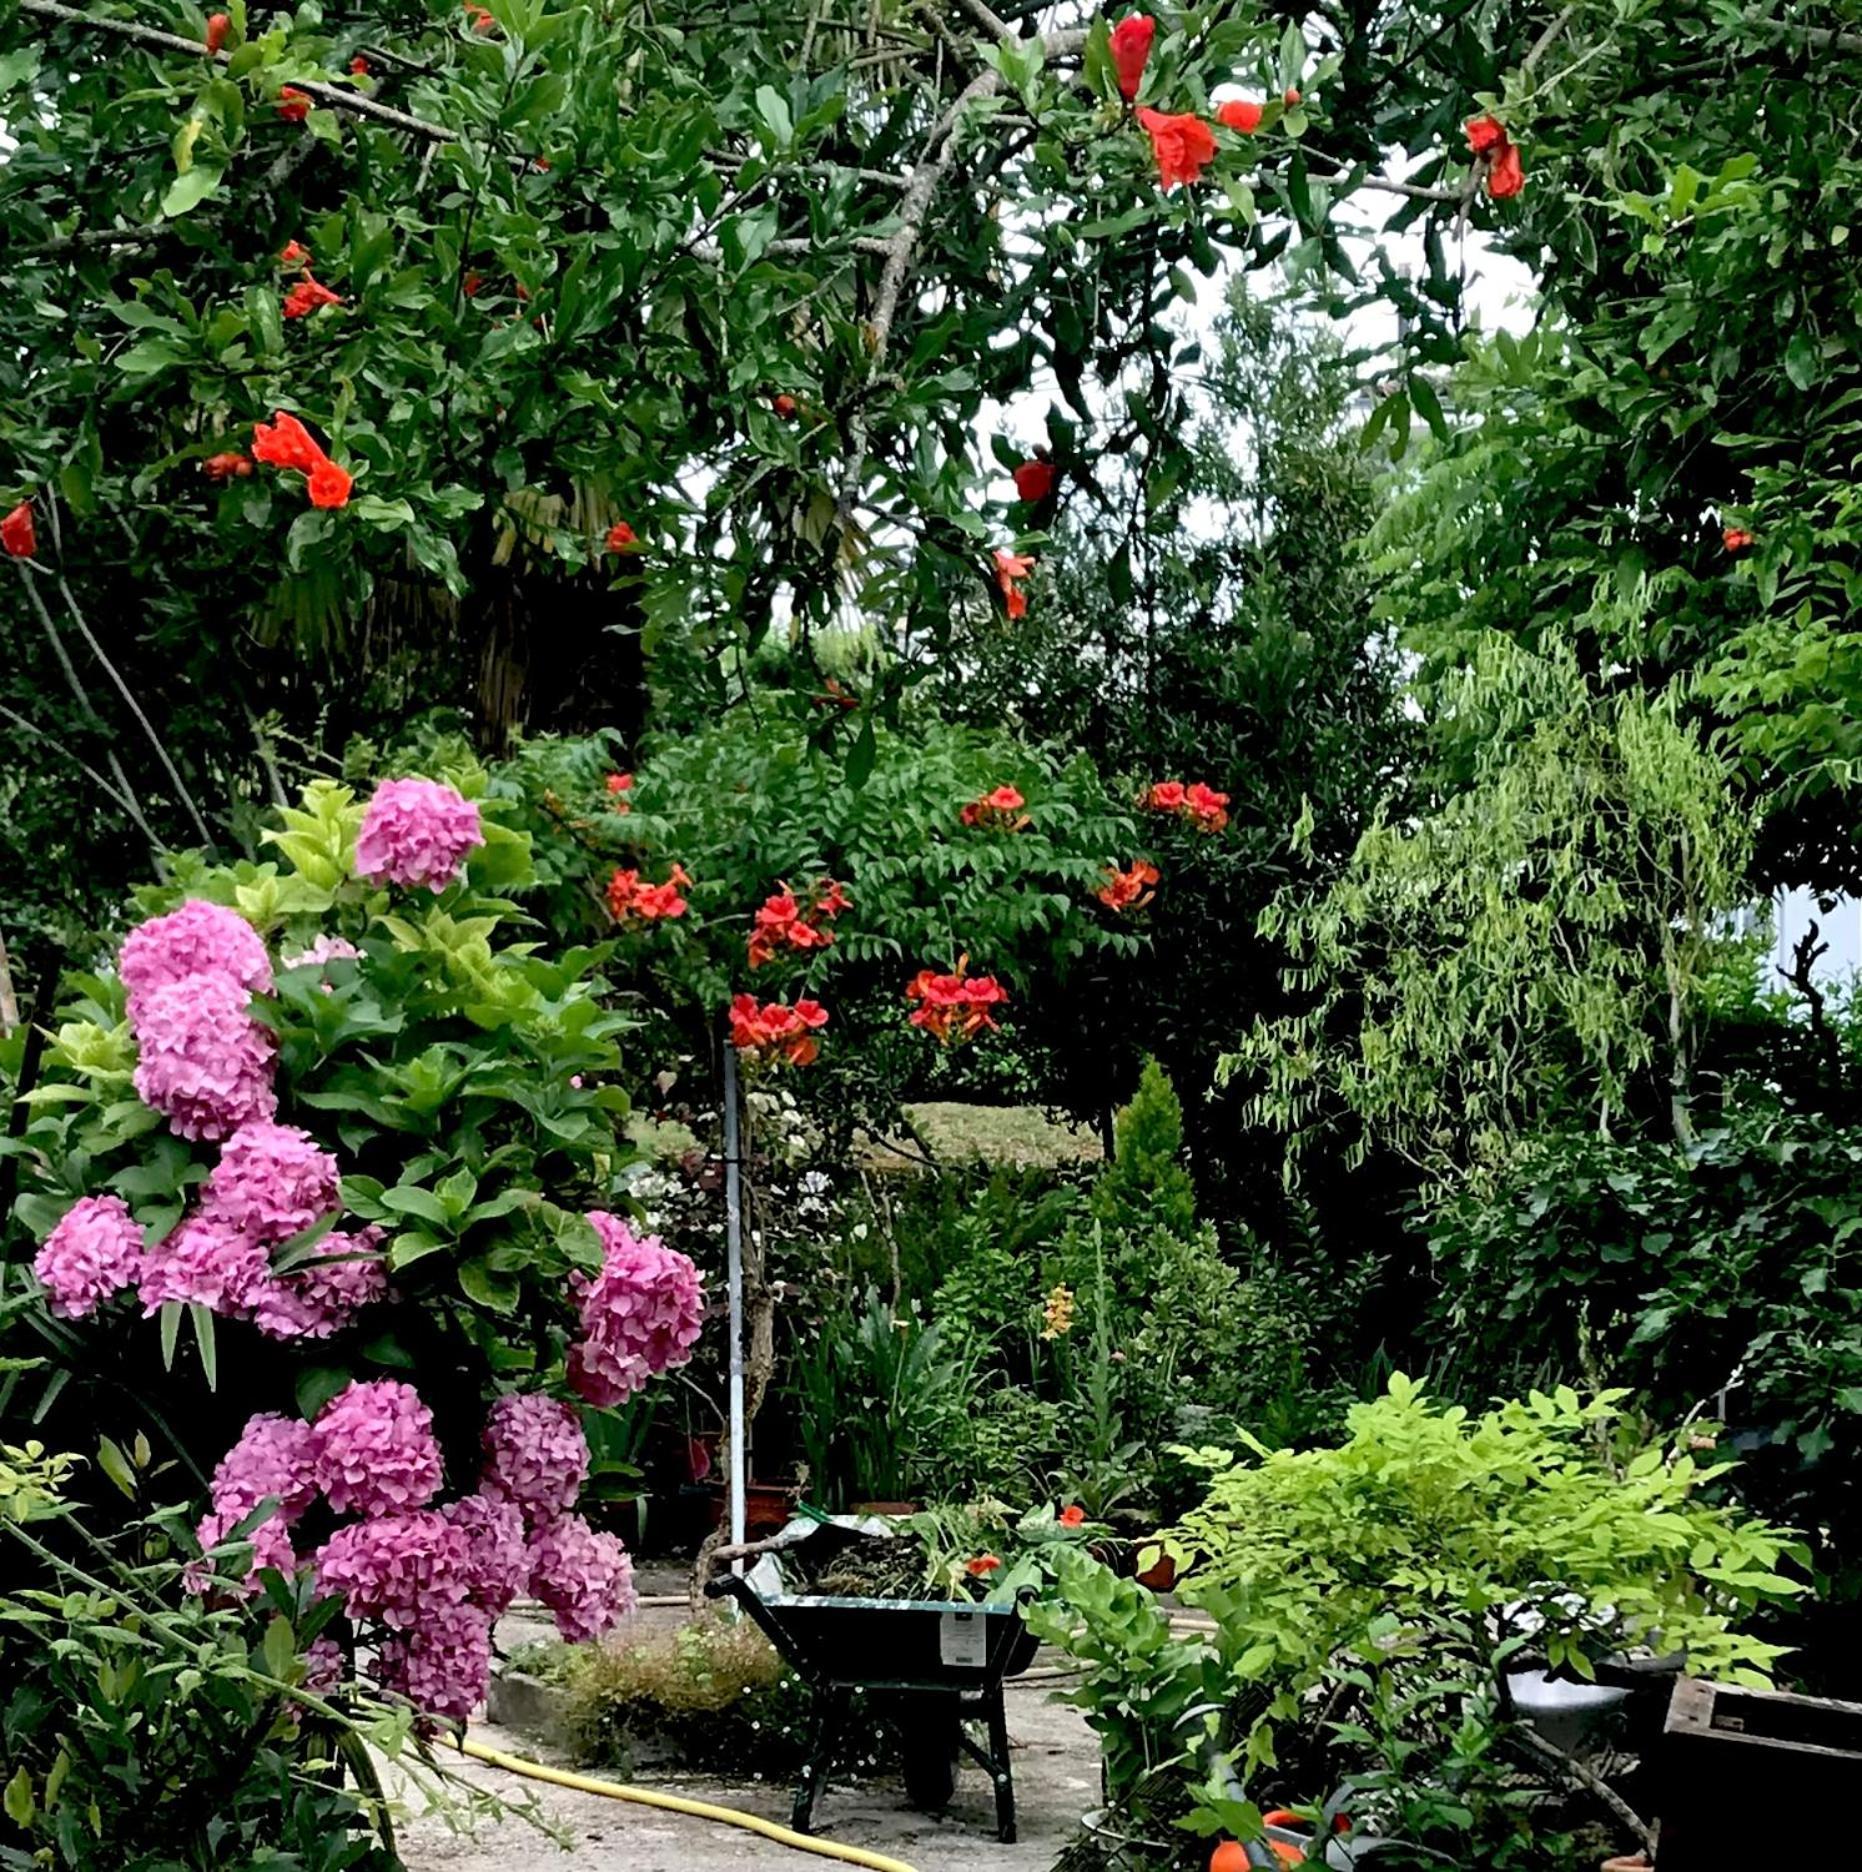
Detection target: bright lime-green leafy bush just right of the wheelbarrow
<box><xmin>1033</xmin><ymin>1378</ymin><xmax>1798</xmax><ymax>1868</ymax></box>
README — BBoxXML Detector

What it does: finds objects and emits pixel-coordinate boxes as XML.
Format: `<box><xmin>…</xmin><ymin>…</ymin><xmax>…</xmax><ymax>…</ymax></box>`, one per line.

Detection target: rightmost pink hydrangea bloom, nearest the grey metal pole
<box><xmin>569</xmin><ymin>1209</ymin><xmax>706</xmax><ymax>1406</ymax></box>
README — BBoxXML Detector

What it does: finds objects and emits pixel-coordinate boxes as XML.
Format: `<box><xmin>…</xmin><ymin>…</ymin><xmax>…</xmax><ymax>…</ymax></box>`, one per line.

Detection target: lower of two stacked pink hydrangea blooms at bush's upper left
<box><xmin>135</xmin><ymin>973</ymin><xmax>279</xmax><ymax>1140</ymax></box>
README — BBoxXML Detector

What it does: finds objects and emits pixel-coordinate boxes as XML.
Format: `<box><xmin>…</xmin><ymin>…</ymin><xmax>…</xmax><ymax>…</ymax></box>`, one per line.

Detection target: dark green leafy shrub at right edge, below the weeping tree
<box><xmin>1430</xmin><ymin>1091</ymin><xmax>1862</xmax><ymax>1694</ymax></box>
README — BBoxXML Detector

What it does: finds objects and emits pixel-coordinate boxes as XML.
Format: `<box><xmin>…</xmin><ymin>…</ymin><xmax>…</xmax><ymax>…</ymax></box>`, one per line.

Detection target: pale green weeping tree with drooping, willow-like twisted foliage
<box><xmin>1229</xmin><ymin>618</ymin><xmax>1750</xmax><ymax>1172</ymax></box>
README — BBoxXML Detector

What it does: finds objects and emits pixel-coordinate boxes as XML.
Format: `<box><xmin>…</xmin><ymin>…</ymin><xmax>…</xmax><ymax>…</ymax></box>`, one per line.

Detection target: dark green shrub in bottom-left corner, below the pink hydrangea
<box><xmin>0</xmin><ymin>1443</ymin><xmax>498</xmax><ymax>1872</ymax></box>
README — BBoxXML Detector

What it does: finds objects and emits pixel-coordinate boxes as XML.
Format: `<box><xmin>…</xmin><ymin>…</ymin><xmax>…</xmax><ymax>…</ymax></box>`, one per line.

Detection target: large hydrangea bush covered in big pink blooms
<box><xmin>19</xmin><ymin>775</ymin><xmax>704</xmax><ymax>1718</ymax></box>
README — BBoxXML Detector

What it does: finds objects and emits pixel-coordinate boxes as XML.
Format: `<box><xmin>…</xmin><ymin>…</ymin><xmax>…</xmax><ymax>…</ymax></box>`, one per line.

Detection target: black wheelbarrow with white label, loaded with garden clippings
<box><xmin>706</xmin><ymin>1574</ymin><xmax>1039</xmax><ymax>1846</ymax></box>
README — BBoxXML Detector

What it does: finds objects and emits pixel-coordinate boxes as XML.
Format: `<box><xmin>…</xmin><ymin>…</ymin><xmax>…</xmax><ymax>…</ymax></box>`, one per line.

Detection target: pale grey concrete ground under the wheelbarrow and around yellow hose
<box><xmin>389</xmin><ymin>1574</ymin><xmax>1098</xmax><ymax>1872</ymax></box>
